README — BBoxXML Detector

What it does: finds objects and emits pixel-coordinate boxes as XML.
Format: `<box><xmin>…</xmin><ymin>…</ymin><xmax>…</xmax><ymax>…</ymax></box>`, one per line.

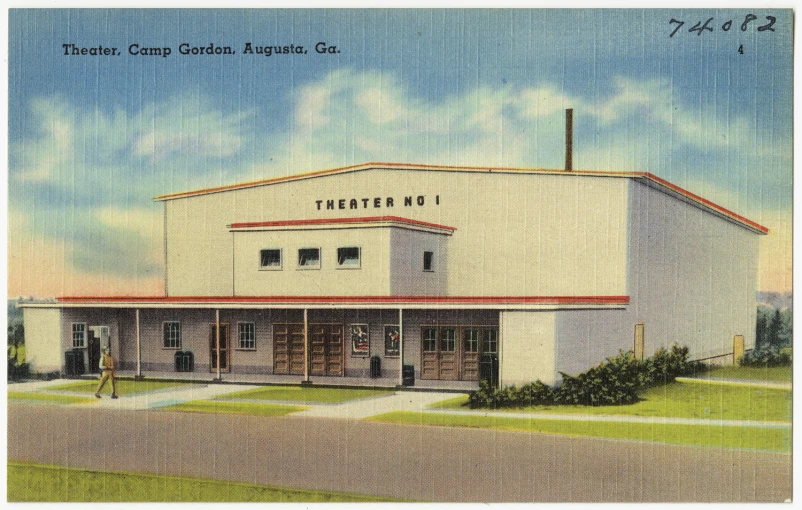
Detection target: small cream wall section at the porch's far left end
<box><xmin>23</xmin><ymin>307</ymin><xmax>64</xmax><ymax>372</ymax></box>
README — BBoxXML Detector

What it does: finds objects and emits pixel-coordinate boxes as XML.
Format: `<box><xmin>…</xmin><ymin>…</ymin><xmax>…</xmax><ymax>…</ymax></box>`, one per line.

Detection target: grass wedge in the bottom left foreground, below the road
<box><xmin>7</xmin><ymin>462</ymin><xmax>400</xmax><ymax>503</ymax></box>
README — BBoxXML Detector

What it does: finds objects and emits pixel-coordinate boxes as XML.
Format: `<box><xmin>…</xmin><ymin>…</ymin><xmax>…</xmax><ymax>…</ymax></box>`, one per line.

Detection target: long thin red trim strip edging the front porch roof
<box><xmin>57</xmin><ymin>296</ymin><xmax>629</xmax><ymax>305</ymax></box>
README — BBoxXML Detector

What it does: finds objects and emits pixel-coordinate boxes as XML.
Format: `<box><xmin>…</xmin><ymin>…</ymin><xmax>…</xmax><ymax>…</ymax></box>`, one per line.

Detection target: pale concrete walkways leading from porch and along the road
<box><xmin>8</xmin><ymin>380</ymin><xmax>791</xmax><ymax>428</ymax></box>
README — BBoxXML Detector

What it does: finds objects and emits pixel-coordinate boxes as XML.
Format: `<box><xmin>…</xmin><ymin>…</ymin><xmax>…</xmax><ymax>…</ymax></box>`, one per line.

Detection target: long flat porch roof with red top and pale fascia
<box><xmin>26</xmin><ymin>296</ymin><xmax>630</xmax><ymax>310</ymax></box>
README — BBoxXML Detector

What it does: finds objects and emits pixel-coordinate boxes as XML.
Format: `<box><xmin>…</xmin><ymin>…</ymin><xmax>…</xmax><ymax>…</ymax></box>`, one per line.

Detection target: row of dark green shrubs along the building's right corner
<box><xmin>469</xmin><ymin>345</ymin><xmax>704</xmax><ymax>409</ymax></box>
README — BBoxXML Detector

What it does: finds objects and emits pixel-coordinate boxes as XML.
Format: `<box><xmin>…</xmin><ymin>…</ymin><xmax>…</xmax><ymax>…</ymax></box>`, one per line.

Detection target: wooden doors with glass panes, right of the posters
<box><xmin>420</xmin><ymin>326</ymin><xmax>498</xmax><ymax>381</ymax></box>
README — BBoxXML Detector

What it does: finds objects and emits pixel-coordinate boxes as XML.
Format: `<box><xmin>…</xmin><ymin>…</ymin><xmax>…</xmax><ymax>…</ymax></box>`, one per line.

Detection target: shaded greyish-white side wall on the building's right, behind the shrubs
<box><xmin>557</xmin><ymin>181</ymin><xmax>761</xmax><ymax>374</ymax></box>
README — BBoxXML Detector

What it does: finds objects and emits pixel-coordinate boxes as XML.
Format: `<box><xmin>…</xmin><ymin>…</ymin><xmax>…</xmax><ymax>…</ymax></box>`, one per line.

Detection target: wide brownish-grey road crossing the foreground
<box><xmin>8</xmin><ymin>402</ymin><xmax>792</xmax><ymax>502</ymax></box>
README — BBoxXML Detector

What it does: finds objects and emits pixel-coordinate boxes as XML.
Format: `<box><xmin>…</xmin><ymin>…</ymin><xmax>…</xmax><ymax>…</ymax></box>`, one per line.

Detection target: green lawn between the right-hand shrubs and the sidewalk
<box><xmin>437</xmin><ymin>382</ymin><xmax>792</xmax><ymax>422</ymax></box>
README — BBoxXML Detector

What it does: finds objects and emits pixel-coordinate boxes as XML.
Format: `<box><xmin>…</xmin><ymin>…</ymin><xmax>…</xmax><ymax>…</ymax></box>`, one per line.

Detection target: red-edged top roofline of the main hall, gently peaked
<box><xmin>154</xmin><ymin>162</ymin><xmax>769</xmax><ymax>234</ymax></box>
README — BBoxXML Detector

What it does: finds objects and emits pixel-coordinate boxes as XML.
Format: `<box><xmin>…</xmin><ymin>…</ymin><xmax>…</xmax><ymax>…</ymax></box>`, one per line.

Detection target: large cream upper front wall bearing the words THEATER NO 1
<box><xmin>165</xmin><ymin>169</ymin><xmax>629</xmax><ymax>296</ymax></box>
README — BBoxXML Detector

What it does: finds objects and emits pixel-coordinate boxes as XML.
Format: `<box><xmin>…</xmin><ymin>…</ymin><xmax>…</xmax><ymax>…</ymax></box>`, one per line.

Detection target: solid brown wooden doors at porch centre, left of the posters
<box><xmin>273</xmin><ymin>323</ymin><xmax>345</xmax><ymax>376</ymax></box>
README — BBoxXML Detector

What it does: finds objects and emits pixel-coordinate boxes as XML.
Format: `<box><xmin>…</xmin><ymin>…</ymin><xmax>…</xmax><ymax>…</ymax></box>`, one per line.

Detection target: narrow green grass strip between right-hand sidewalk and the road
<box><xmin>369</xmin><ymin>411</ymin><xmax>791</xmax><ymax>453</ymax></box>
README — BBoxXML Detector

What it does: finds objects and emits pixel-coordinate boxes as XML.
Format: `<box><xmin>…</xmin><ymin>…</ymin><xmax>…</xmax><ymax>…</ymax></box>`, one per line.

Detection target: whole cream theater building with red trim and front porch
<box><xmin>25</xmin><ymin>163</ymin><xmax>767</xmax><ymax>388</ymax></box>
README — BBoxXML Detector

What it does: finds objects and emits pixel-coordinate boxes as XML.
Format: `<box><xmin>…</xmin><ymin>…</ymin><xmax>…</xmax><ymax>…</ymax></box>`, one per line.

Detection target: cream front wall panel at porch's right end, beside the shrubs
<box><xmin>499</xmin><ymin>311</ymin><xmax>557</xmax><ymax>387</ymax></box>
